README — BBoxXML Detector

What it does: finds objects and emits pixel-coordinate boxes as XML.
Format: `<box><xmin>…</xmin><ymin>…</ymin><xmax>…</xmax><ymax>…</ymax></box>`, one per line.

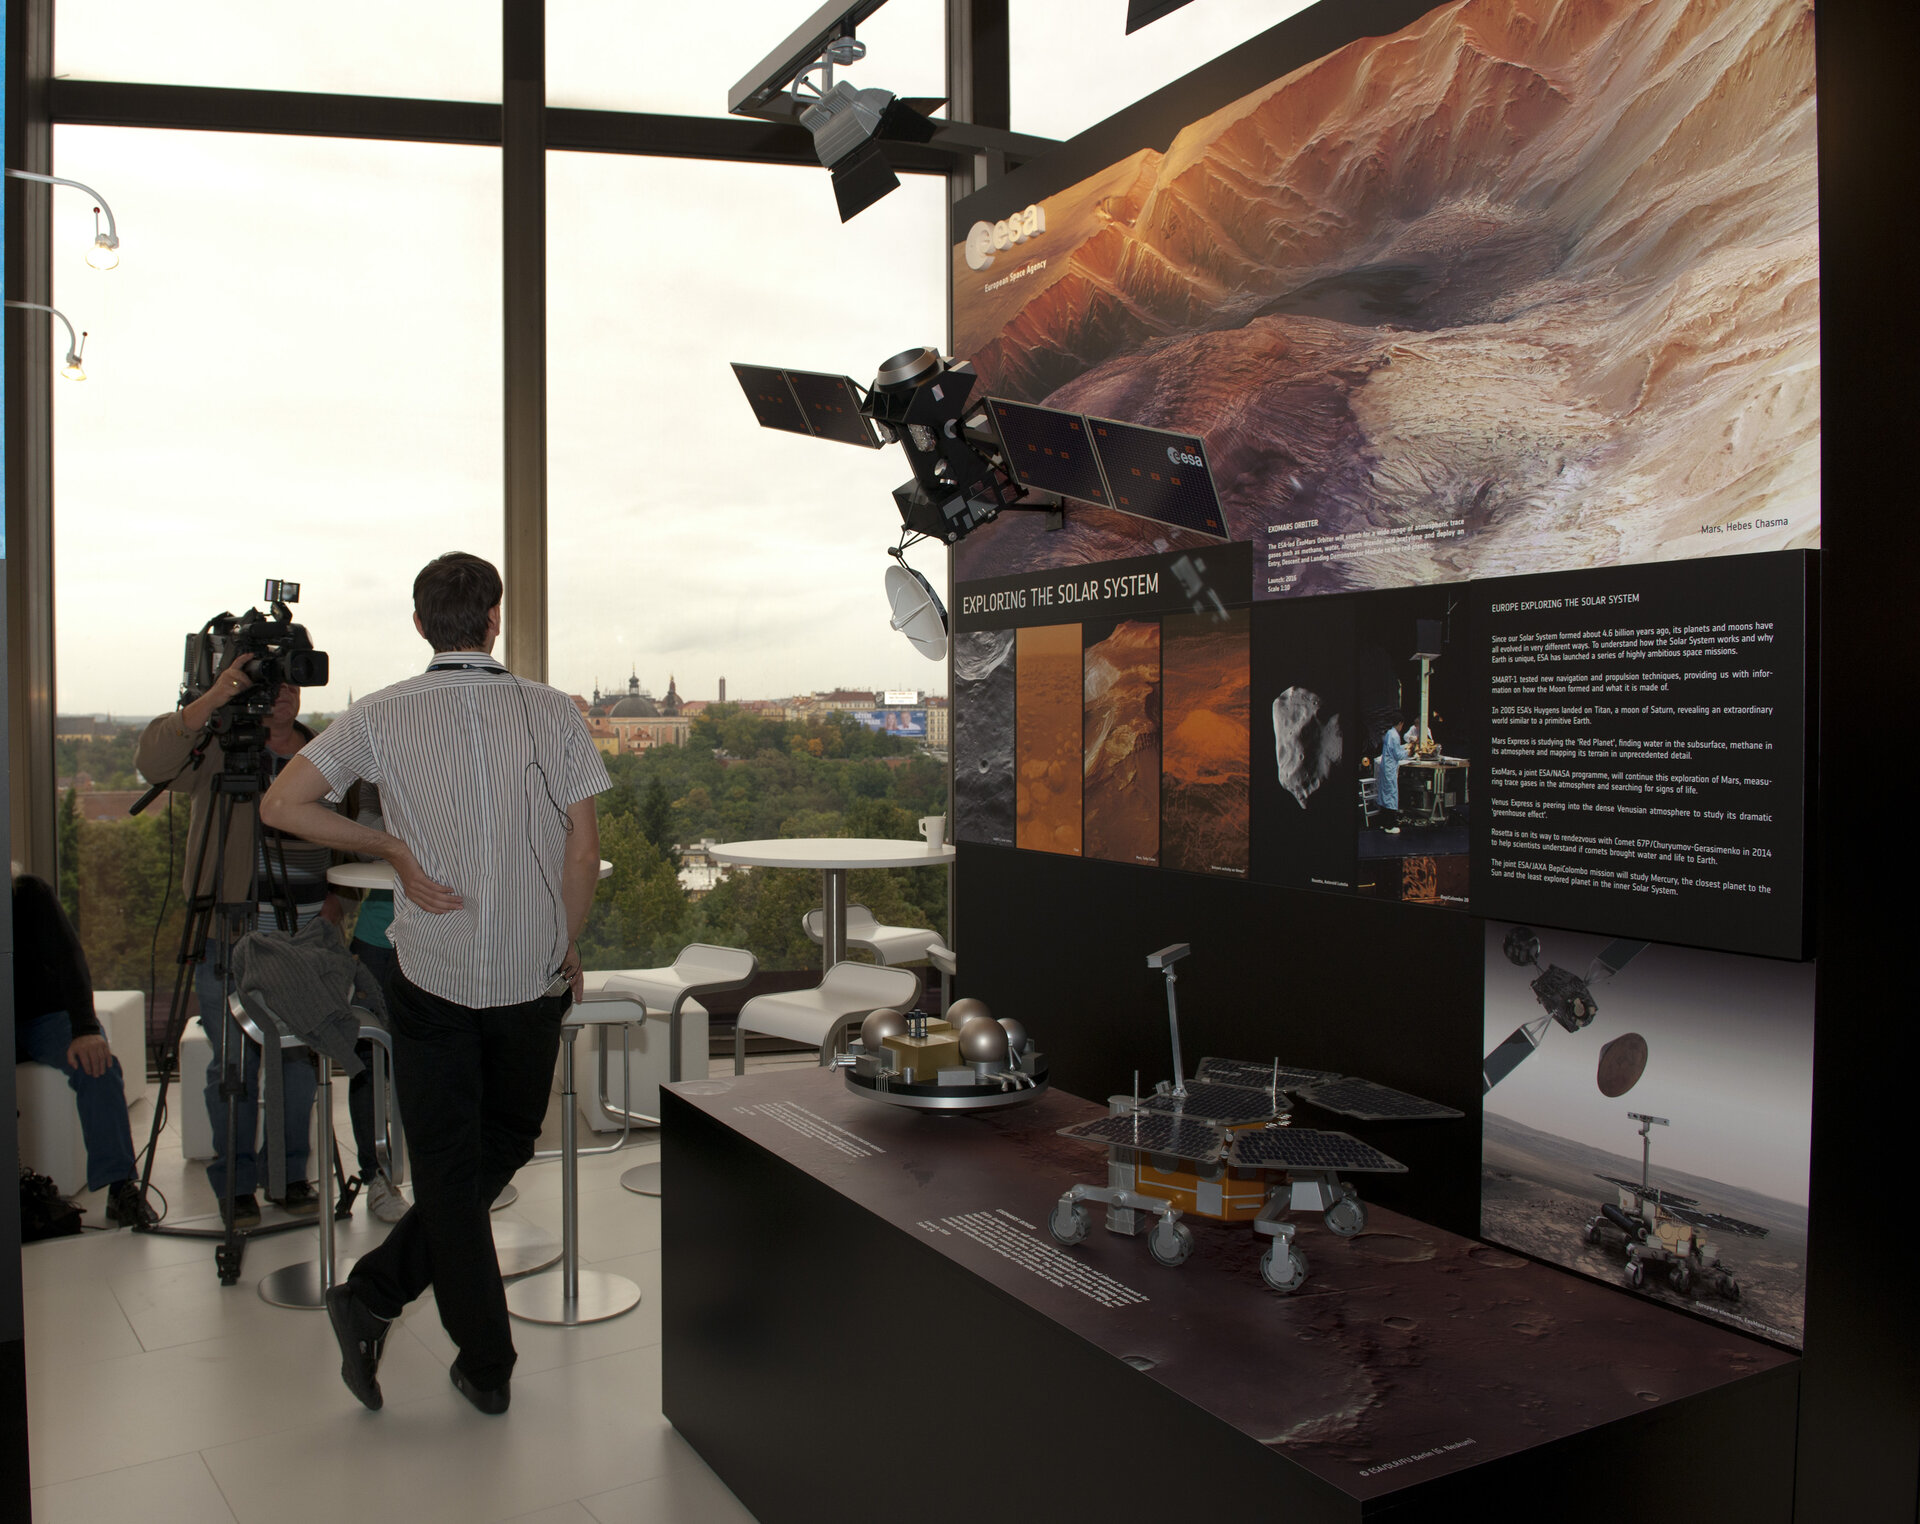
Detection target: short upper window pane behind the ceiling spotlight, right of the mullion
<box><xmin>547</xmin><ymin>0</ymin><xmax>947</xmax><ymax>117</ymax></box>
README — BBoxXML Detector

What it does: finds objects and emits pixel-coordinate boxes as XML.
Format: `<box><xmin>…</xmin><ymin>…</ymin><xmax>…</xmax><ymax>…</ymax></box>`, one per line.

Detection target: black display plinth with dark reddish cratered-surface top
<box><xmin>662</xmin><ymin>1069</ymin><xmax>1799</xmax><ymax>1524</ymax></box>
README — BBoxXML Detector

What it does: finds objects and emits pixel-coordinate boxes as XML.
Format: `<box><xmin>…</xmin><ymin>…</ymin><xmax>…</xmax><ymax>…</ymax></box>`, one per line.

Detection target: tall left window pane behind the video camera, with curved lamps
<box><xmin>51</xmin><ymin>127</ymin><xmax>501</xmax><ymax>1021</ymax></box>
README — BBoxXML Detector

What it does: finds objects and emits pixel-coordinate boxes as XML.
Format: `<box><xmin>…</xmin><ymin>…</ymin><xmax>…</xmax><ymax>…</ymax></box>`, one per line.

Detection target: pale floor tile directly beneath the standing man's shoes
<box><xmin>207</xmin><ymin>1349</ymin><xmax>684</xmax><ymax>1524</ymax></box>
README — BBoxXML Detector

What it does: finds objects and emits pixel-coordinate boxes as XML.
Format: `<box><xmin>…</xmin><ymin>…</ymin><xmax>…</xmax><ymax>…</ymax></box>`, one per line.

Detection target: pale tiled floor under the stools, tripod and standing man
<box><xmin>23</xmin><ymin>1058</ymin><xmax>812</xmax><ymax>1524</ymax></box>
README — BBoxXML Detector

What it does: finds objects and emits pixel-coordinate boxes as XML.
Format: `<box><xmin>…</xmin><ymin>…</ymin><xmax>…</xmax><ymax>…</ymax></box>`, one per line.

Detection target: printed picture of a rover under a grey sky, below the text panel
<box><xmin>1480</xmin><ymin>923</ymin><xmax>1814</xmax><ymax>1349</ymax></box>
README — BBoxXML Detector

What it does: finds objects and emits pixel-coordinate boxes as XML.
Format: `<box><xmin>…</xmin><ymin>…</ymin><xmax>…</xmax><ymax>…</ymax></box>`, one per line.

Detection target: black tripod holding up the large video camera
<box><xmin>129</xmin><ymin>712</ymin><xmax>353</xmax><ymax>1286</ymax></box>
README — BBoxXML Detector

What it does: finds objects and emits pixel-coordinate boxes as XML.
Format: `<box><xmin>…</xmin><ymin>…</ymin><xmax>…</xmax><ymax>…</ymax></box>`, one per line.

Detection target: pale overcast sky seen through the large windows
<box><xmin>45</xmin><ymin>0</ymin><xmax>1302</xmax><ymax>714</ymax></box>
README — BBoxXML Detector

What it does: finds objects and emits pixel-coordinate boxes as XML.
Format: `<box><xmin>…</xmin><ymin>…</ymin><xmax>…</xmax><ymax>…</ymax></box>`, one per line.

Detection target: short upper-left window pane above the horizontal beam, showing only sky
<box><xmin>54</xmin><ymin>0</ymin><xmax>501</xmax><ymax>100</ymax></box>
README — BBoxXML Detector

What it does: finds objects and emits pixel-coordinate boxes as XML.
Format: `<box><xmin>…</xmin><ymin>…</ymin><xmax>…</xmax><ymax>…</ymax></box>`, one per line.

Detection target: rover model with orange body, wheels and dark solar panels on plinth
<box><xmin>1046</xmin><ymin>942</ymin><xmax>1461</xmax><ymax>1292</ymax></box>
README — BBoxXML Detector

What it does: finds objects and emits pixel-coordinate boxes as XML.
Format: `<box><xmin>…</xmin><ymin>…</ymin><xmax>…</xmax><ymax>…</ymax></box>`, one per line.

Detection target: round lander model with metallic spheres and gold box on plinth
<box><xmin>833</xmin><ymin>1000</ymin><xmax>1046</xmax><ymax>1111</ymax></box>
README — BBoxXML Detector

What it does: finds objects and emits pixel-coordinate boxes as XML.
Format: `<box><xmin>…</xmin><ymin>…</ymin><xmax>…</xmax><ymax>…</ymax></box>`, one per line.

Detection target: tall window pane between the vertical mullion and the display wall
<box><xmin>547</xmin><ymin>154</ymin><xmax>947</xmax><ymax>969</ymax></box>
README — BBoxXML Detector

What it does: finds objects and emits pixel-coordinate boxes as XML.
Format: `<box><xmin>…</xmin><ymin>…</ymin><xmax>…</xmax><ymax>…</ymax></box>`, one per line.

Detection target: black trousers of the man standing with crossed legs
<box><xmin>351</xmin><ymin>969</ymin><xmax>572</xmax><ymax>1392</ymax></box>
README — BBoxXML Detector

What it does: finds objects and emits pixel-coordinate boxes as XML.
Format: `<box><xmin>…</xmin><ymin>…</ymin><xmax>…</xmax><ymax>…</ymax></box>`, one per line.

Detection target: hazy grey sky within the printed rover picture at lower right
<box><xmin>1486</xmin><ymin>921</ymin><xmax>1814</xmax><ymax>1205</ymax></box>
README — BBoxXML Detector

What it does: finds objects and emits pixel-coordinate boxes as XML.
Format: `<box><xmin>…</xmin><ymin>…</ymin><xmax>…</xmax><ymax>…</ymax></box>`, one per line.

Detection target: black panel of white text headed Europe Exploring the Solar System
<box><xmin>1471</xmin><ymin>551</ymin><xmax>1812</xmax><ymax>958</ymax></box>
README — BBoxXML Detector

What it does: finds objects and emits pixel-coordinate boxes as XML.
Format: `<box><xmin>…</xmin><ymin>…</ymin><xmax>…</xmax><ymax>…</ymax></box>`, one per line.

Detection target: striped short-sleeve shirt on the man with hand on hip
<box><xmin>301</xmin><ymin>651</ymin><xmax>612</xmax><ymax>1010</ymax></box>
